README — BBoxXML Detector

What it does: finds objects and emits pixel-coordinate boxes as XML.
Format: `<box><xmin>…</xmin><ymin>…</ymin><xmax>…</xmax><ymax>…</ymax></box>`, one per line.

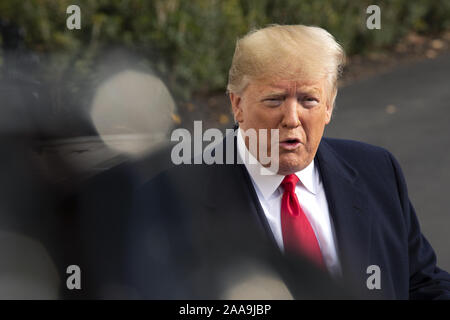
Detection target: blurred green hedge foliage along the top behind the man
<box><xmin>0</xmin><ymin>0</ymin><xmax>450</xmax><ymax>100</ymax></box>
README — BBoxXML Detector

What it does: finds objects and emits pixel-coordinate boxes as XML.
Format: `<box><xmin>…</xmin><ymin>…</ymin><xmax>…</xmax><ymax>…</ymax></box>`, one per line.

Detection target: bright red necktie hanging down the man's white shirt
<box><xmin>281</xmin><ymin>174</ymin><xmax>325</xmax><ymax>268</ymax></box>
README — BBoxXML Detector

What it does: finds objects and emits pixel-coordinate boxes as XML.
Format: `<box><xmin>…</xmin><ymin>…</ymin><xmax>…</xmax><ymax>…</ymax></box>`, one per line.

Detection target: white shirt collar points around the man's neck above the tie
<box><xmin>237</xmin><ymin>128</ymin><xmax>319</xmax><ymax>200</ymax></box>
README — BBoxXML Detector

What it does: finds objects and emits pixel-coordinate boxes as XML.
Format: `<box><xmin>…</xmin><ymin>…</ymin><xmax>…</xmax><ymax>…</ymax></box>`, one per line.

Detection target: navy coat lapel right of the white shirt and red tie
<box><xmin>316</xmin><ymin>139</ymin><xmax>371</xmax><ymax>287</ymax></box>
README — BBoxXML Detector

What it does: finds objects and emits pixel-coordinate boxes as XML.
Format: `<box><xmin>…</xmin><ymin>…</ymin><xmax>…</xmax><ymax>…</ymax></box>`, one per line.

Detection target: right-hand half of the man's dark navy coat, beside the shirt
<box><xmin>316</xmin><ymin>139</ymin><xmax>450</xmax><ymax>299</ymax></box>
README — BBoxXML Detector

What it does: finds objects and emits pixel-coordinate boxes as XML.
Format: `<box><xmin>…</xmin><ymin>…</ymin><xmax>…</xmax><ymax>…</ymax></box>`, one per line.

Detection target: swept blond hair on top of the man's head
<box><xmin>227</xmin><ymin>25</ymin><xmax>345</xmax><ymax>101</ymax></box>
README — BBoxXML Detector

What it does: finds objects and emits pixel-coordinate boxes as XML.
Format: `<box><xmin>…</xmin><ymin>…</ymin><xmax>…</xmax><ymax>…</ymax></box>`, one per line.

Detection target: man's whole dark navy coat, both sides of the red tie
<box><xmin>128</xmin><ymin>134</ymin><xmax>450</xmax><ymax>299</ymax></box>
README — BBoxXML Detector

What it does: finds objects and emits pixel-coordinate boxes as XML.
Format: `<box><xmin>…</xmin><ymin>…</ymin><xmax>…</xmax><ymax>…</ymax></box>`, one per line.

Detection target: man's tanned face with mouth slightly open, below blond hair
<box><xmin>230</xmin><ymin>80</ymin><xmax>333</xmax><ymax>175</ymax></box>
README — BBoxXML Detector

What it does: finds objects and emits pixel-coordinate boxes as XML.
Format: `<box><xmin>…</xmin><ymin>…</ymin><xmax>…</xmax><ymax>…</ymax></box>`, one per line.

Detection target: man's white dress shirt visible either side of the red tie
<box><xmin>237</xmin><ymin>129</ymin><xmax>341</xmax><ymax>275</ymax></box>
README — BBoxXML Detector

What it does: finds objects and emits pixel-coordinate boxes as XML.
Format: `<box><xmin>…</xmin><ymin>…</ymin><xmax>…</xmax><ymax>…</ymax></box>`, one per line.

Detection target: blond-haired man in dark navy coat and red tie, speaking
<box><xmin>128</xmin><ymin>25</ymin><xmax>450</xmax><ymax>299</ymax></box>
